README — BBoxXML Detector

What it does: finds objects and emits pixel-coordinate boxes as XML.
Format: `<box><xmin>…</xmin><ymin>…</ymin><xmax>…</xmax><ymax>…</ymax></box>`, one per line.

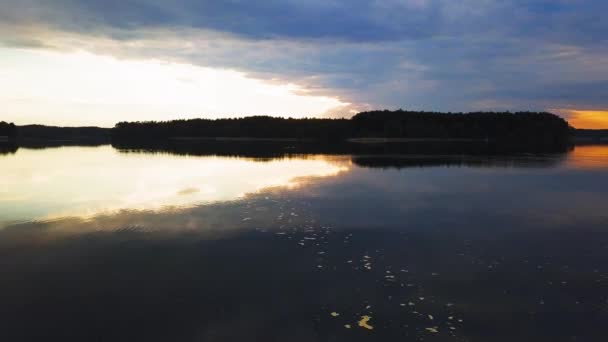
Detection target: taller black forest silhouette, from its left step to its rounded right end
<box><xmin>112</xmin><ymin>110</ymin><xmax>573</xmax><ymax>145</ymax></box>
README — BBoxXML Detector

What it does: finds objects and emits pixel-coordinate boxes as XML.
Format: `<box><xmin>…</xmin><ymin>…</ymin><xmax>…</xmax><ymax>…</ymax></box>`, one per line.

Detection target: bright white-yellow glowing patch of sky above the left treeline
<box><xmin>0</xmin><ymin>48</ymin><xmax>348</xmax><ymax>127</ymax></box>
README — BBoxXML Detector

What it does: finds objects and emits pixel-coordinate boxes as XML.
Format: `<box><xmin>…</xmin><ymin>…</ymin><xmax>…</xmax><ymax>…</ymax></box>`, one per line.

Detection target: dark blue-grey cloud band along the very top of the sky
<box><xmin>0</xmin><ymin>0</ymin><xmax>608</xmax><ymax>43</ymax></box>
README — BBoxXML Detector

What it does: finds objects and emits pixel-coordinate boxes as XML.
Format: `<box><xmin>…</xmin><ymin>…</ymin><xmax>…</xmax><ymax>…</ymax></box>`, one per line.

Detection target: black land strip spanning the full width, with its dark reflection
<box><xmin>0</xmin><ymin>110</ymin><xmax>607</xmax><ymax>153</ymax></box>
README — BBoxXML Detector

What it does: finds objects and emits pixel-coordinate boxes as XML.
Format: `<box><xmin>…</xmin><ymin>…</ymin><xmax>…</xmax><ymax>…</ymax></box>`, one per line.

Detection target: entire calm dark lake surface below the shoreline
<box><xmin>0</xmin><ymin>146</ymin><xmax>608</xmax><ymax>342</ymax></box>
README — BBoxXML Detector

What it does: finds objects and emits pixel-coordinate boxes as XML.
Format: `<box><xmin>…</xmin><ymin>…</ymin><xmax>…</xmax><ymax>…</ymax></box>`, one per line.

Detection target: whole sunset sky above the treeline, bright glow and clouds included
<box><xmin>0</xmin><ymin>0</ymin><xmax>608</xmax><ymax>128</ymax></box>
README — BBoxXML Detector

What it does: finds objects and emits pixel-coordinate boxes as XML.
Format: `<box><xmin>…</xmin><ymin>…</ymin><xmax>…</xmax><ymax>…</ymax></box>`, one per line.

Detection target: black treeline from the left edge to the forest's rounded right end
<box><xmin>0</xmin><ymin>110</ymin><xmax>590</xmax><ymax>147</ymax></box>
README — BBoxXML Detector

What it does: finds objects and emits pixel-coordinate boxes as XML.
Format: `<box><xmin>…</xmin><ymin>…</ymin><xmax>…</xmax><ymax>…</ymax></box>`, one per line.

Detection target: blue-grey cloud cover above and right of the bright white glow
<box><xmin>0</xmin><ymin>0</ymin><xmax>608</xmax><ymax>110</ymax></box>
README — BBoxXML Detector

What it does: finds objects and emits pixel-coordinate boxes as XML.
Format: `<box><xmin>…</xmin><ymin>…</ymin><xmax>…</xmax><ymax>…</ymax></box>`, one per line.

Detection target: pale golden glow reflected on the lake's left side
<box><xmin>0</xmin><ymin>146</ymin><xmax>349</xmax><ymax>223</ymax></box>
